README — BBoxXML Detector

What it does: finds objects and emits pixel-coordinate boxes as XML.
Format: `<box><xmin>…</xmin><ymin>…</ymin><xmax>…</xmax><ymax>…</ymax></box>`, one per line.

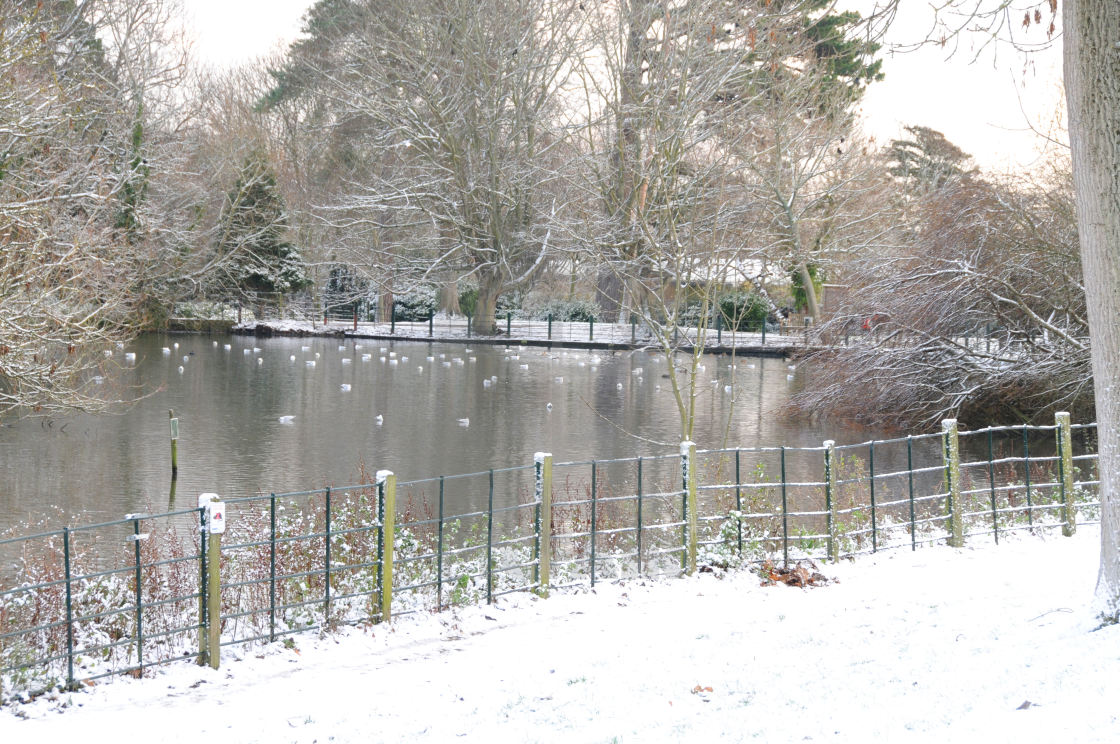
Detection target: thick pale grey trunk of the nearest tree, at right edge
<box><xmin>1062</xmin><ymin>0</ymin><xmax>1120</xmax><ymax>622</ymax></box>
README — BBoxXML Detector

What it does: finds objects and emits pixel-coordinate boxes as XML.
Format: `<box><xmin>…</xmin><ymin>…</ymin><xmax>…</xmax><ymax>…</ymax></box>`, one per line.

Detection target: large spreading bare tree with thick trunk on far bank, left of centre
<box><xmin>256</xmin><ymin>0</ymin><xmax>580</xmax><ymax>333</ymax></box>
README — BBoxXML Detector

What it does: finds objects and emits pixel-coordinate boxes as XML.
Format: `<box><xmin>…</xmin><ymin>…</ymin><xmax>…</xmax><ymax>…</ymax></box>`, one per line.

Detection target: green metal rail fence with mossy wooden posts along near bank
<box><xmin>0</xmin><ymin>413</ymin><xmax>1100</xmax><ymax>703</ymax></box>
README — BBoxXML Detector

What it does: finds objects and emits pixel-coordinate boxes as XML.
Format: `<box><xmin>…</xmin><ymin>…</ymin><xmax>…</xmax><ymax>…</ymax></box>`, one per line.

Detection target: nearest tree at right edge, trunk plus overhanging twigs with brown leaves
<box><xmin>860</xmin><ymin>0</ymin><xmax>1120</xmax><ymax>623</ymax></box>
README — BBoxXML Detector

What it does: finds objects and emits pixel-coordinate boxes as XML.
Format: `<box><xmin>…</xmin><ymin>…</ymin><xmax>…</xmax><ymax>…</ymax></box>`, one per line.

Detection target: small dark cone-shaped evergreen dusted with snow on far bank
<box><xmin>216</xmin><ymin>150</ymin><xmax>311</xmax><ymax>315</ymax></box>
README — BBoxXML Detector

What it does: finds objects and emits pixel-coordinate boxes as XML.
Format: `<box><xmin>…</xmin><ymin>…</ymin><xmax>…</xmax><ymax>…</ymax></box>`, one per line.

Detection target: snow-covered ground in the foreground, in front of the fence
<box><xmin>0</xmin><ymin>528</ymin><xmax>1120</xmax><ymax>744</ymax></box>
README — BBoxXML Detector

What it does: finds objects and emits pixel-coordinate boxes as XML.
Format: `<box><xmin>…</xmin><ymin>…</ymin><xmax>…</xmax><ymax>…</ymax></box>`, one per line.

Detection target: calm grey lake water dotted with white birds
<box><xmin>0</xmin><ymin>335</ymin><xmax>874</xmax><ymax>532</ymax></box>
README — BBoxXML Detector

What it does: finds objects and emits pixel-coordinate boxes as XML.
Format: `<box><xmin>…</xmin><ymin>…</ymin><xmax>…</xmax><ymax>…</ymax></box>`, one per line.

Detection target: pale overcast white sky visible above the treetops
<box><xmin>185</xmin><ymin>0</ymin><xmax>1062</xmax><ymax>169</ymax></box>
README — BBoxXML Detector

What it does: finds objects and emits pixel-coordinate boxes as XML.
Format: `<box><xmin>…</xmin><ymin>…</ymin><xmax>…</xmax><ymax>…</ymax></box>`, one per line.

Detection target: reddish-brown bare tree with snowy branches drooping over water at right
<box><xmin>793</xmin><ymin>163</ymin><xmax>1092</xmax><ymax>426</ymax></box>
